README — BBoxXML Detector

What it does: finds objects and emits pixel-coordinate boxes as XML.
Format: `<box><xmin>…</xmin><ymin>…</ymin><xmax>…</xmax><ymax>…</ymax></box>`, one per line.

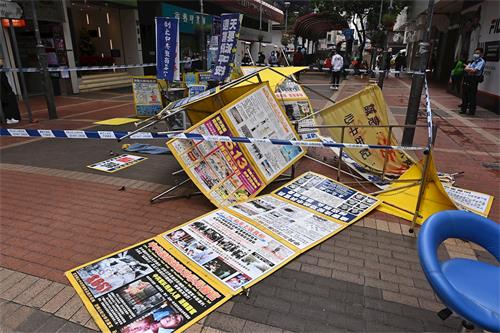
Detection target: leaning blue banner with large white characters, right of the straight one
<box><xmin>211</xmin><ymin>13</ymin><xmax>243</xmax><ymax>81</ymax></box>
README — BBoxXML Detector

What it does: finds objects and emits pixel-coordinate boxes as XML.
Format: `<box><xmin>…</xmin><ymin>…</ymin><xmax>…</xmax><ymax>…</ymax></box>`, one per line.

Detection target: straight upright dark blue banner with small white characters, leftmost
<box><xmin>155</xmin><ymin>17</ymin><xmax>180</xmax><ymax>82</ymax></box>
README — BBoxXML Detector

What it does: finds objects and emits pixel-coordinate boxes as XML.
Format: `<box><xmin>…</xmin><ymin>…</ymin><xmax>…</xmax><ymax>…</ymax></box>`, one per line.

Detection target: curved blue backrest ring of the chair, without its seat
<box><xmin>418</xmin><ymin>210</ymin><xmax>500</xmax><ymax>325</ymax></box>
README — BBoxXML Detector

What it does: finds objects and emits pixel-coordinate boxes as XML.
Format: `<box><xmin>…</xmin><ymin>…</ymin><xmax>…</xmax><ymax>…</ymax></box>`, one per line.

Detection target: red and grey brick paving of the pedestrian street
<box><xmin>0</xmin><ymin>74</ymin><xmax>500</xmax><ymax>333</ymax></box>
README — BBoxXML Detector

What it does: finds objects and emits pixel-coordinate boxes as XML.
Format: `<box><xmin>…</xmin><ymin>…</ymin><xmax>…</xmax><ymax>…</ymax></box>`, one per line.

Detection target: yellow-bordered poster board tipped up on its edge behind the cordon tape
<box><xmin>167</xmin><ymin>83</ymin><xmax>305</xmax><ymax>207</ymax></box>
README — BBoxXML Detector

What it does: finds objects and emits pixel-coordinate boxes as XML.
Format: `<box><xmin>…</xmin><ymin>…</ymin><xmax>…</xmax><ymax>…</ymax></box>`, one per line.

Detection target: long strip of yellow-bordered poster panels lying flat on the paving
<box><xmin>65</xmin><ymin>172</ymin><xmax>378</xmax><ymax>332</ymax></box>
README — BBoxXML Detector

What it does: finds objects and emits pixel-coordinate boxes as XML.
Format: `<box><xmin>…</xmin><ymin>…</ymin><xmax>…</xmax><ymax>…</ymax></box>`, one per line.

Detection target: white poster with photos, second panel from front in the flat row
<box><xmin>163</xmin><ymin>210</ymin><xmax>295</xmax><ymax>291</ymax></box>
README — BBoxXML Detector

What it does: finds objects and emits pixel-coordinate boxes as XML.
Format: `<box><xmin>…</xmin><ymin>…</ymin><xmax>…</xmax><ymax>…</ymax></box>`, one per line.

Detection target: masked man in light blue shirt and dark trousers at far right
<box><xmin>460</xmin><ymin>47</ymin><xmax>486</xmax><ymax>116</ymax></box>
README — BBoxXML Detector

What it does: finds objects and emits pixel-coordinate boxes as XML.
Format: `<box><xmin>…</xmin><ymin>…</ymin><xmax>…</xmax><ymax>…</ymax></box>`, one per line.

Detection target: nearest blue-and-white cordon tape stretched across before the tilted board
<box><xmin>0</xmin><ymin>128</ymin><xmax>427</xmax><ymax>150</ymax></box>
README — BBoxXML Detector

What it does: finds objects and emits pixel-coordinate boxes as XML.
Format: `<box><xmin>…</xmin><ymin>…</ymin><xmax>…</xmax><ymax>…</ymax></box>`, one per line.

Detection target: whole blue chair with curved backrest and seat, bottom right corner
<box><xmin>418</xmin><ymin>211</ymin><xmax>500</xmax><ymax>332</ymax></box>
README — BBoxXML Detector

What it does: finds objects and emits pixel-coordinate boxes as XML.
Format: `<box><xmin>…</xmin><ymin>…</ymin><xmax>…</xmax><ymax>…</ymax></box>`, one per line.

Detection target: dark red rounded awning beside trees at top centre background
<box><xmin>294</xmin><ymin>12</ymin><xmax>349</xmax><ymax>40</ymax></box>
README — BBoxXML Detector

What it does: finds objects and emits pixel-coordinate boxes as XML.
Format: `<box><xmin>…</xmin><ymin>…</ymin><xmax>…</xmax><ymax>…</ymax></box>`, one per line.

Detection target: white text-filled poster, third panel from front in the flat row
<box><xmin>227</xmin><ymin>195</ymin><xmax>344</xmax><ymax>250</ymax></box>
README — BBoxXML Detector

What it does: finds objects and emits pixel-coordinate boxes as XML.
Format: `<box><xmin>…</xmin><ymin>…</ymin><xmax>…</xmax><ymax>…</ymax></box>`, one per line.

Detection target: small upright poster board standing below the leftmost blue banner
<box><xmin>132</xmin><ymin>76</ymin><xmax>163</xmax><ymax>117</ymax></box>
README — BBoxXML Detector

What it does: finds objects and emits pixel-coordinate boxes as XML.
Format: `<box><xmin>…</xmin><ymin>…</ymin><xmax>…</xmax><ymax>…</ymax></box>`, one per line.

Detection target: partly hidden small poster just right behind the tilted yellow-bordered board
<box><xmin>282</xmin><ymin>100</ymin><xmax>319</xmax><ymax>140</ymax></box>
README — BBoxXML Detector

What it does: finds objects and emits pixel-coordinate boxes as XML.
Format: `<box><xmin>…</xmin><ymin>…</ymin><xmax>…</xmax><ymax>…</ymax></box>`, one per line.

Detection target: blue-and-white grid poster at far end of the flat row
<box><xmin>273</xmin><ymin>172</ymin><xmax>380</xmax><ymax>223</ymax></box>
